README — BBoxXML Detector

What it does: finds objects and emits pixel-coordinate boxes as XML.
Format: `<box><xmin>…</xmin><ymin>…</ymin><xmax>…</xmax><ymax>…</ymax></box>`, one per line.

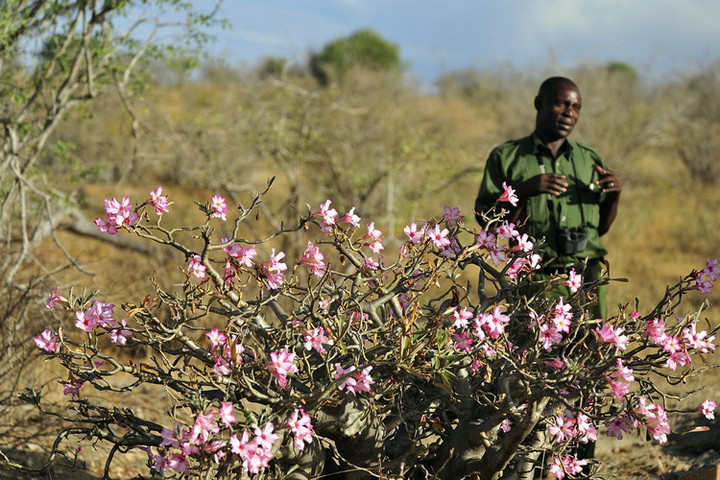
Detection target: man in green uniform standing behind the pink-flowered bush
<box><xmin>475</xmin><ymin>77</ymin><xmax>622</xmax><ymax>318</ymax></box>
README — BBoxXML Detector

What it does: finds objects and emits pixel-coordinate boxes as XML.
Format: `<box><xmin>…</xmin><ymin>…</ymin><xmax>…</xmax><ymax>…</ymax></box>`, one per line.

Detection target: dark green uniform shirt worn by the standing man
<box><xmin>475</xmin><ymin>134</ymin><xmax>607</xmax><ymax>266</ymax></box>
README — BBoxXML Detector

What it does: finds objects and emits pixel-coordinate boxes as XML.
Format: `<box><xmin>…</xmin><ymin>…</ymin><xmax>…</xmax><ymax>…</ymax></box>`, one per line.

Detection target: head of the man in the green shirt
<box><xmin>535</xmin><ymin>77</ymin><xmax>582</xmax><ymax>142</ymax></box>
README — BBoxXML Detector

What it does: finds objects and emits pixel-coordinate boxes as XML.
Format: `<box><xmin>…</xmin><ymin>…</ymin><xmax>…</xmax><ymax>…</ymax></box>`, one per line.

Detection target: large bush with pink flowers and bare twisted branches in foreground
<box><xmin>24</xmin><ymin>182</ymin><xmax>720</xmax><ymax>479</ymax></box>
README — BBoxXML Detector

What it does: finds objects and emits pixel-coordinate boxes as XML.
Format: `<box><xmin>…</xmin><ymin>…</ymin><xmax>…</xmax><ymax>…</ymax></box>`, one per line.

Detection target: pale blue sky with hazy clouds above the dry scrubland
<box><xmin>181</xmin><ymin>0</ymin><xmax>720</xmax><ymax>83</ymax></box>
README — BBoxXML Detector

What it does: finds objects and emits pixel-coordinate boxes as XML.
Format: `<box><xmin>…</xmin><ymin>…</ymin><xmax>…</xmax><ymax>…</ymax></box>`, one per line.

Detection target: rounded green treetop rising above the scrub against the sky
<box><xmin>310</xmin><ymin>29</ymin><xmax>401</xmax><ymax>85</ymax></box>
